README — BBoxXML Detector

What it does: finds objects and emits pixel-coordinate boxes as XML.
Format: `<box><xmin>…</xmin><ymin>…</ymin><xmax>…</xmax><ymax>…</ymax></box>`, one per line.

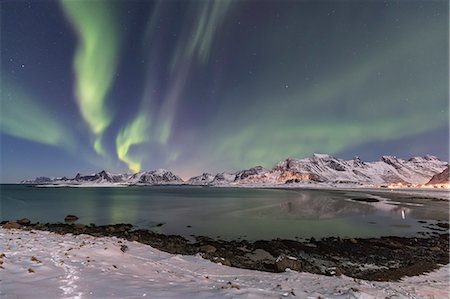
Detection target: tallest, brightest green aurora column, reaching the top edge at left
<box><xmin>61</xmin><ymin>0</ymin><xmax>121</xmax><ymax>154</ymax></box>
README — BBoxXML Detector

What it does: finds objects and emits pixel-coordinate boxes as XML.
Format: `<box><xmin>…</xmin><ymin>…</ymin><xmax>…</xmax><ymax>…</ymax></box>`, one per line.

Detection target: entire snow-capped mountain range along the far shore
<box><xmin>21</xmin><ymin>154</ymin><xmax>449</xmax><ymax>186</ymax></box>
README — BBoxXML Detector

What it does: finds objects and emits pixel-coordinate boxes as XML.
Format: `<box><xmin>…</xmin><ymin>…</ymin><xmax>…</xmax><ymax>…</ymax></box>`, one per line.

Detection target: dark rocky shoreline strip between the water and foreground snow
<box><xmin>0</xmin><ymin>216</ymin><xmax>450</xmax><ymax>281</ymax></box>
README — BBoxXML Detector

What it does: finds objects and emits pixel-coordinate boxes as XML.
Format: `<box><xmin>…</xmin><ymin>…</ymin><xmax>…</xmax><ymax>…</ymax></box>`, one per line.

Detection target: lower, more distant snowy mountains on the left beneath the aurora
<box><xmin>21</xmin><ymin>169</ymin><xmax>183</xmax><ymax>185</ymax></box>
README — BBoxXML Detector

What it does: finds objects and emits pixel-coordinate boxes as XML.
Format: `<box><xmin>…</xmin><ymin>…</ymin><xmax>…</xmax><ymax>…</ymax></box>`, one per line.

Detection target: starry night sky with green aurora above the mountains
<box><xmin>0</xmin><ymin>0</ymin><xmax>449</xmax><ymax>182</ymax></box>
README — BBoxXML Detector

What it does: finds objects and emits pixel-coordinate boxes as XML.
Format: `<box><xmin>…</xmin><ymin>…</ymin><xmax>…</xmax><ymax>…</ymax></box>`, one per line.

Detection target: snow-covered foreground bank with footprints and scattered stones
<box><xmin>0</xmin><ymin>228</ymin><xmax>450</xmax><ymax>298</ymax></box>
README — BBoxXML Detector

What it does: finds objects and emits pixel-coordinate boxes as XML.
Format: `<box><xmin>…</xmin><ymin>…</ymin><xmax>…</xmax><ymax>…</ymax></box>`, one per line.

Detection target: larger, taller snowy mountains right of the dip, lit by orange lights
<box><xmin>188</xmin><ymin>154</ymin><xmax>448</xmax><ymax>186</ymax></box>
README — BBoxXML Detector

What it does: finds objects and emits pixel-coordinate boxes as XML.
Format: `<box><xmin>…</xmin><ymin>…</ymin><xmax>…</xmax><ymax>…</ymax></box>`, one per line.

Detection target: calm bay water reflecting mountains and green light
<box><xmin>0</xmin><ymin>185</ymin><xmax>449</xmax><ymax>240</ymax></box>
